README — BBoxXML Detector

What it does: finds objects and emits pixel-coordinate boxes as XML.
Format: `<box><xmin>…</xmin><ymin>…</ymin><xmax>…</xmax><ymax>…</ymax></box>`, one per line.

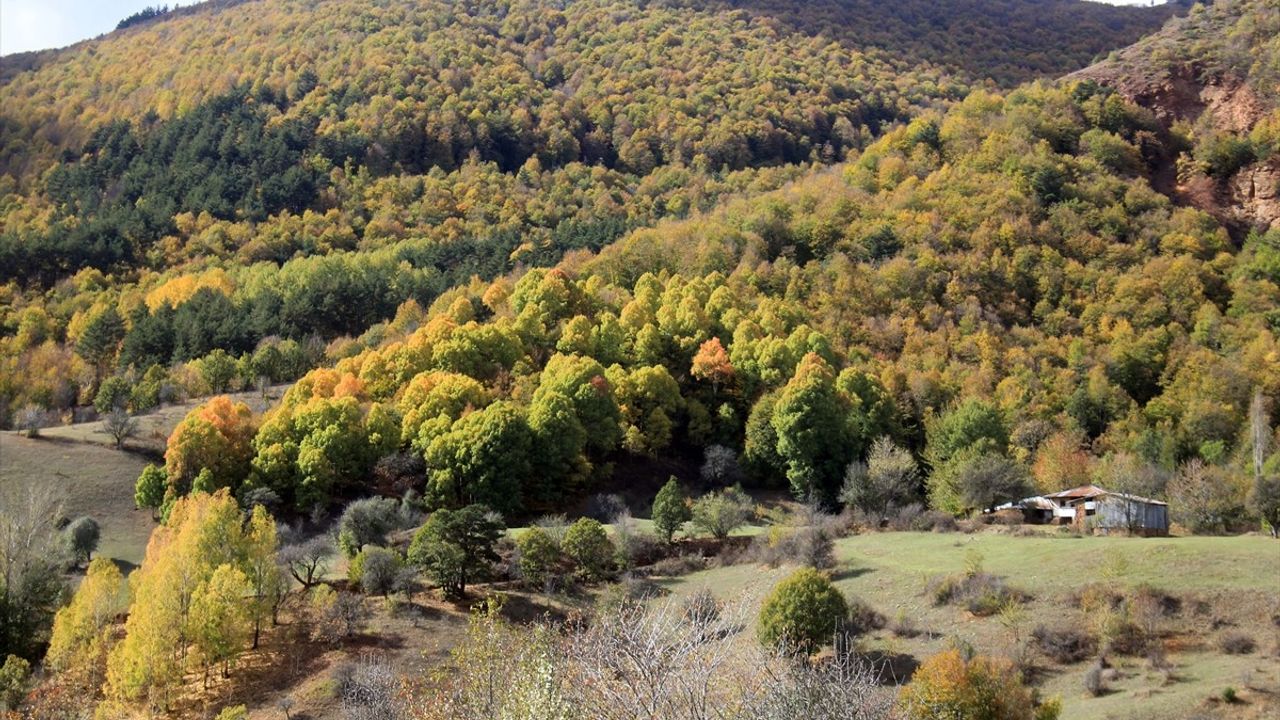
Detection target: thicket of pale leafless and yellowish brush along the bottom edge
<box><xmin>412</xmin><ymin>598</ymin><xmax>893</xmax><ymax>720</ymax></box>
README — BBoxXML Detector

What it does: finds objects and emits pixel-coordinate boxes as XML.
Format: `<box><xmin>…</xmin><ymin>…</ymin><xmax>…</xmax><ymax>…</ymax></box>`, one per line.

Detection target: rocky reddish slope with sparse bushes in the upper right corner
<box><xmin>1071</xmin><ymin>0</ymin><xmax>1280</xmax><ymax>233</ymax></box>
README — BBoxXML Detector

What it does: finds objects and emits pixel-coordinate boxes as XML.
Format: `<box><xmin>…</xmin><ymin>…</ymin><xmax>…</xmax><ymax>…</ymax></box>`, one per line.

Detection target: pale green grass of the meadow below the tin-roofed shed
<box><xmin>660</xmin><ymin>532</ymin><xmax>1280</xmax><ymax>720</ymax></box>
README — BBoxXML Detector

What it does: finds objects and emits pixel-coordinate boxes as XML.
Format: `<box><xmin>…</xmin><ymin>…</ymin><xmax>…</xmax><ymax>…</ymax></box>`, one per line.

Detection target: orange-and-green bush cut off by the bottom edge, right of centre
<box><xmin>899</xmin><ymin>650</ymin><xmax>1039</xmax><ymax>720</ymax></box>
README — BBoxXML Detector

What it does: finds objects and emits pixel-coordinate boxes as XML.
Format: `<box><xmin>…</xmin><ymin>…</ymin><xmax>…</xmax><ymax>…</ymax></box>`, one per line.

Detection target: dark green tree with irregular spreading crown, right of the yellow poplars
<box><xmin>408</xmin><ymin>505</ymin><xmax>504</xmax><ymax>598</ymax></box>
